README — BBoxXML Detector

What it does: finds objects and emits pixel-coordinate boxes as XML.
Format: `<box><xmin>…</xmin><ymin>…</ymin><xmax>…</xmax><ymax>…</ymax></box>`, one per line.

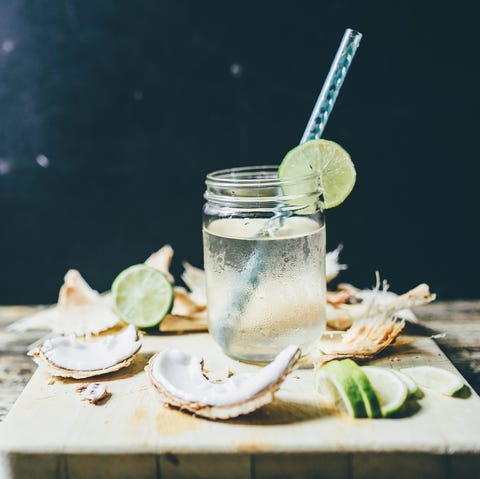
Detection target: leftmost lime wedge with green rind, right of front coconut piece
<box><xmin>315</xmin><ymin>360</ymin><xmax>366</xmax><ymax>417</ymax></box>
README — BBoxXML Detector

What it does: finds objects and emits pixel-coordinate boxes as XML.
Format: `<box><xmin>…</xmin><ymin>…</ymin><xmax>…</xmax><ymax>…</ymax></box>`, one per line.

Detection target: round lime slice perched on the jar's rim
<box><xmin>278</xmin><ymin>140</ymin><xmax>356</xmax><ymax>208</ymax></box>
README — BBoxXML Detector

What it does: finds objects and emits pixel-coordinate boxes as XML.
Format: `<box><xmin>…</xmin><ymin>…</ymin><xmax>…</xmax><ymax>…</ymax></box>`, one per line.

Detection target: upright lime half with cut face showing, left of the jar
<box><xmin>112</xmin><ymin>264</ymin><xmax>173</xmax><ymax>328</ymax></box>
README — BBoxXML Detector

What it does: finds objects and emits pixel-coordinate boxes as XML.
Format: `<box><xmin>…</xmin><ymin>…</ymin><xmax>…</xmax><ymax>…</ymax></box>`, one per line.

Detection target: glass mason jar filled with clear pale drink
<box><xmin>203</xmin><ymin>166</ymin><xmax>326</xmax><ymax>361</ymax></box>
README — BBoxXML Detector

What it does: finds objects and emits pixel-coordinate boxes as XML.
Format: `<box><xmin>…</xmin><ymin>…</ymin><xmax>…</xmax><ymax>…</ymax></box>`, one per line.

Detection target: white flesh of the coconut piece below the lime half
<box><xmin>40</xmin><ymin>325</ymin><xmax>141</xmax><ymax>371</ymax></box>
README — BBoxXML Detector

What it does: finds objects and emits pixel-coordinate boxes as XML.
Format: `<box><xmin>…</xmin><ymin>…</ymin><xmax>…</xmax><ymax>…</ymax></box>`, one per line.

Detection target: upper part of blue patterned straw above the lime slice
<box><xmin>300</xmin><ymin>28</ymin><xmax>362</xmax><ymax>143</ymax></box>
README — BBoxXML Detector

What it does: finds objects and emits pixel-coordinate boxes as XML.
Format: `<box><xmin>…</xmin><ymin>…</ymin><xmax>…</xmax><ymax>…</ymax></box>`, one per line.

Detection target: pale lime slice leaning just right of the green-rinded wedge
<box><xmin>362</xmin><ymin>366</ymin><xmax>408</xmax><ymax>417</ymax></box>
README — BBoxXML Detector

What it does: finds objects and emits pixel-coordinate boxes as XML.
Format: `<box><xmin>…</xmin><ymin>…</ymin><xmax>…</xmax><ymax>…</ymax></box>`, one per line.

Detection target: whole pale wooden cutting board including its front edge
<box><xmin>0</xmin><ymin>334</ymin><xmax>480</xmax><ymax>479</ymax></box>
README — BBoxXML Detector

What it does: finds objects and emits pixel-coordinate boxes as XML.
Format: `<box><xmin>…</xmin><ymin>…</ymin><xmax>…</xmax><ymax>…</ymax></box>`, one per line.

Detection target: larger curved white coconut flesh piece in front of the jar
<box><xmin>151</xmin><ymin>345</ymin><xmax>299</xmax><ymax>406</ymax></box>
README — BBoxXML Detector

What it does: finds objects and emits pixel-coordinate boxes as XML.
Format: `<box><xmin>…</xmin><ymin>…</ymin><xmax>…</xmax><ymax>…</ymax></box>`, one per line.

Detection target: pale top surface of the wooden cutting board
<box><xmin>0</xmin><ymin>335</ymin><xmax>480</xmax><ymax>454</ymax></box>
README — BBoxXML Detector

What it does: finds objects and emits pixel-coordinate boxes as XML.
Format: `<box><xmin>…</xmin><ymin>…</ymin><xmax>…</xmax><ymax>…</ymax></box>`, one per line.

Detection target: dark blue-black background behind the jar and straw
<box><xmin>0</xmin><ymin>0</ymin><xmax>480</xmax><ymax>304</ymax></box>
